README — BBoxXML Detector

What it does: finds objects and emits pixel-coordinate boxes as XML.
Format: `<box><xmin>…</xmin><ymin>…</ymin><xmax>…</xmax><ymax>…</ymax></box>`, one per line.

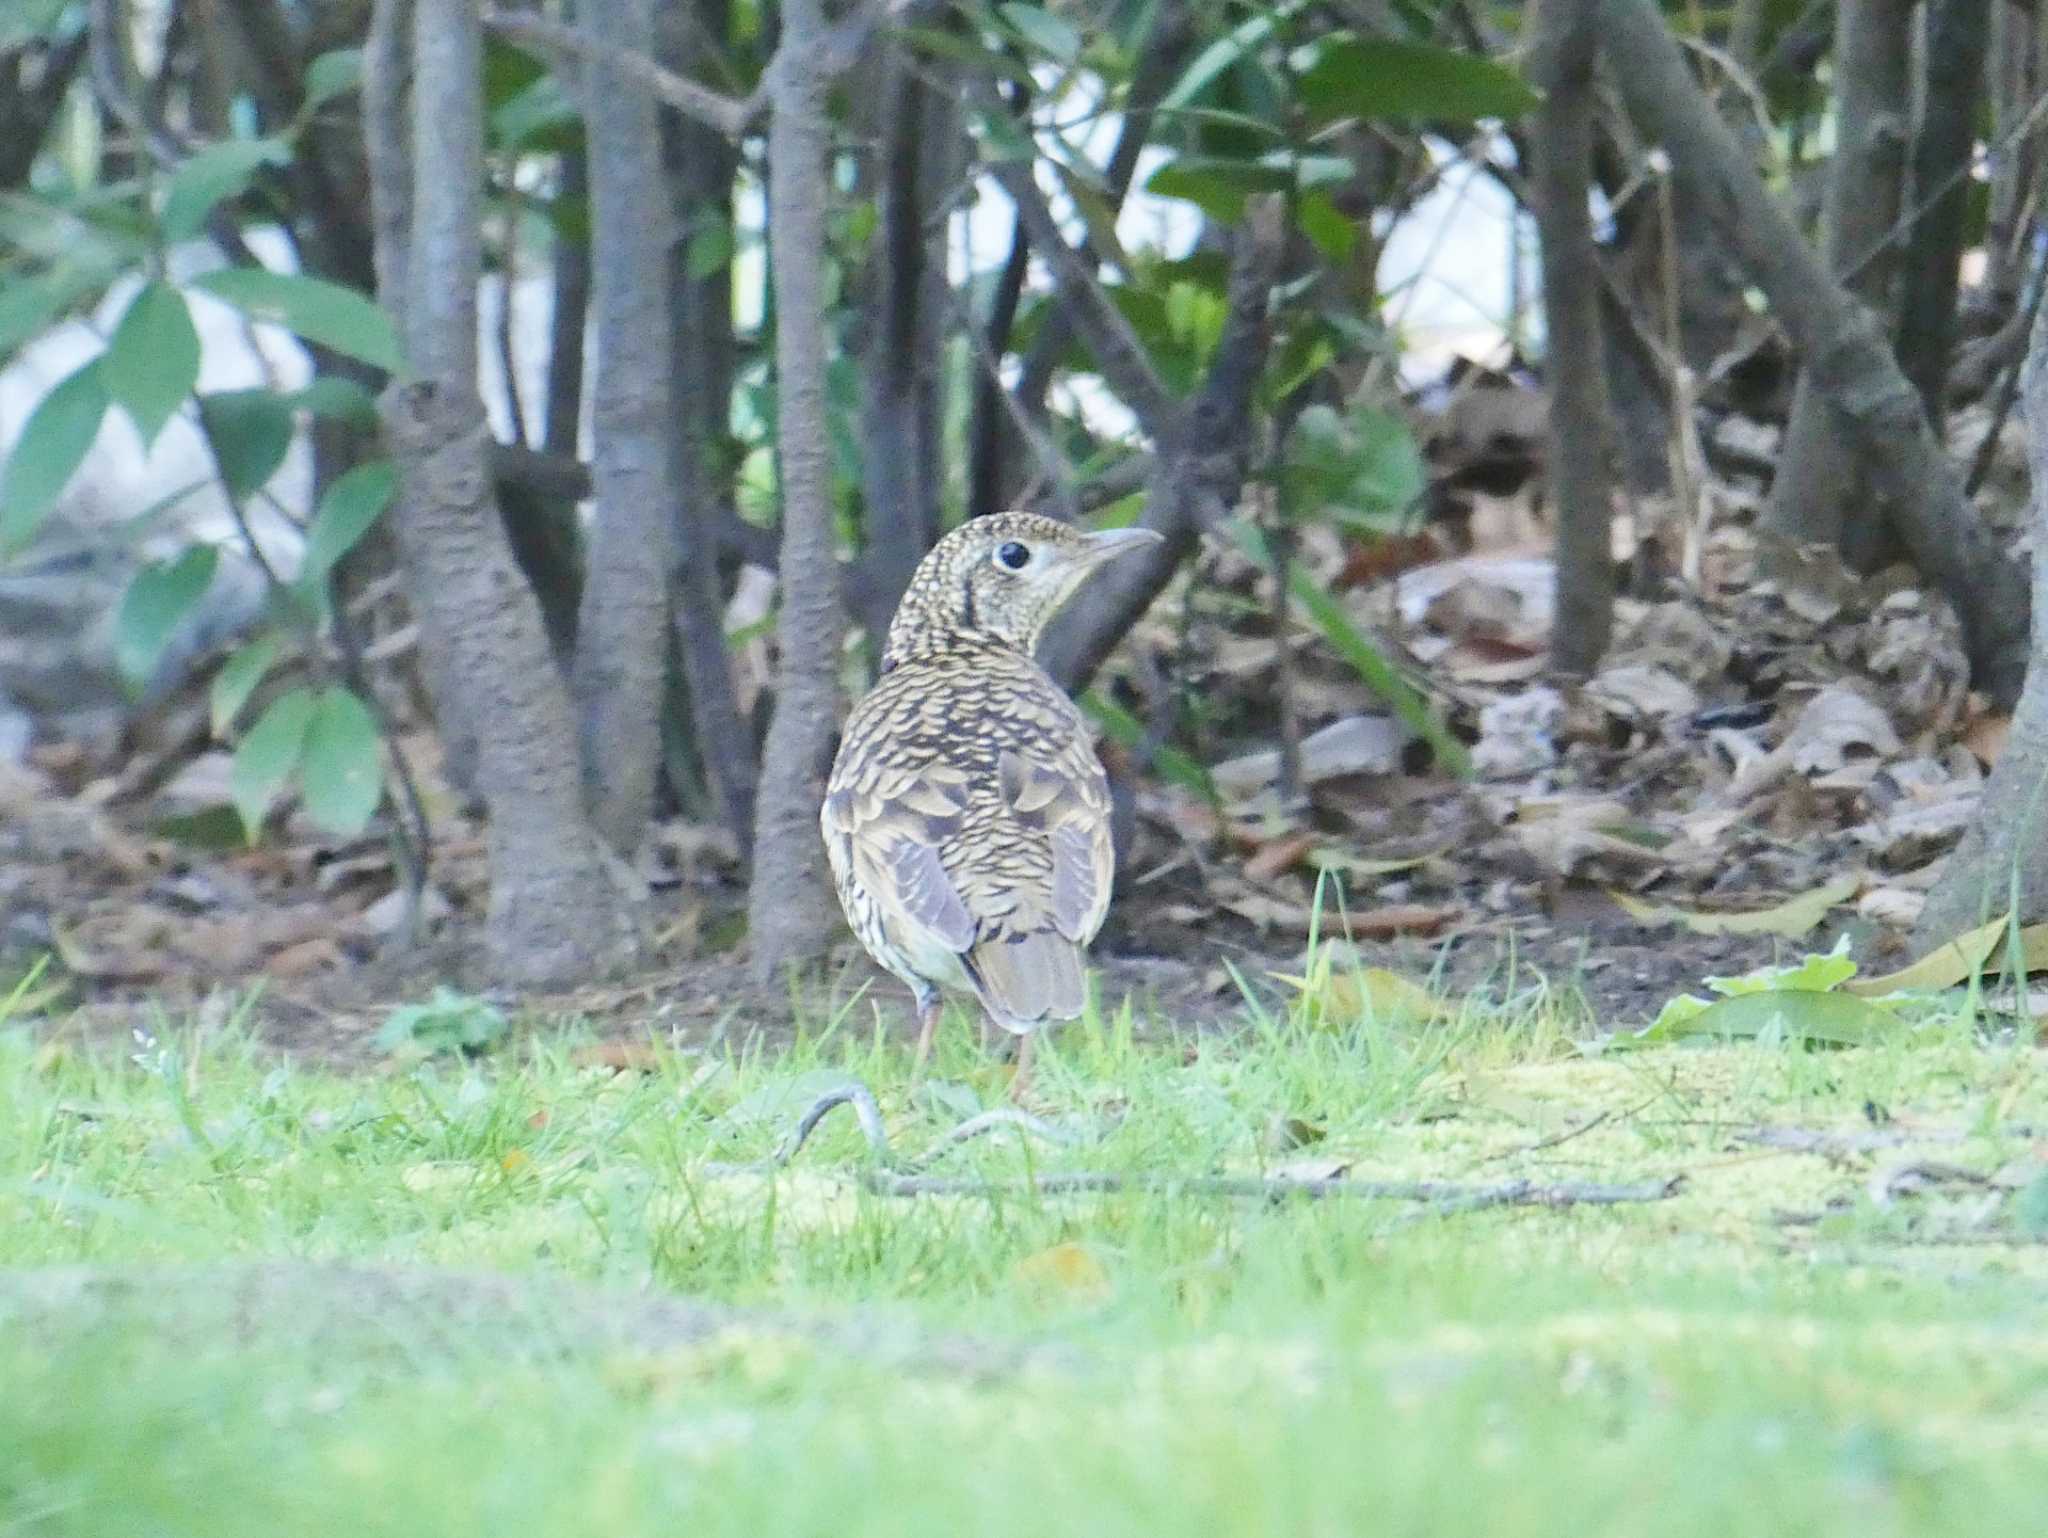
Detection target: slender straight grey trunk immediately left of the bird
<box><xmin>748</xmin><ymin>0</ymin><xmax>846</xmax><ymax>983</ymax></box>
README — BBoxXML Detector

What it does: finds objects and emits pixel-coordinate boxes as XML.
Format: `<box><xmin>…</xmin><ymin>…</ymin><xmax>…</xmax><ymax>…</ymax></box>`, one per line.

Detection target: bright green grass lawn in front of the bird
<box><xmin>0</xmin><ymin>966</ymin><xmax>2048</xmax><ymax>1538</ymax></box>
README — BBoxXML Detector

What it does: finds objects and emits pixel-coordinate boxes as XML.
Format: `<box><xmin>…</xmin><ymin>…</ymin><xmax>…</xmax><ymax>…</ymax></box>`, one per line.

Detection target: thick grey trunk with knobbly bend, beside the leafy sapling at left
<box><xmin>365</xmin><ymin>0</ymin><xmax>631</xmax><ymax>985</ymax></box>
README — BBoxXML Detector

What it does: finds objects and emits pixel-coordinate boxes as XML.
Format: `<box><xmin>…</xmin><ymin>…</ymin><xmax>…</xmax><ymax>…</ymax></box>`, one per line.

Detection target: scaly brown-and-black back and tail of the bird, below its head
<box><xmin>823</xmin><ymin>643</ymin><xmax>1112</xmax><ymax>1030</ymax></box>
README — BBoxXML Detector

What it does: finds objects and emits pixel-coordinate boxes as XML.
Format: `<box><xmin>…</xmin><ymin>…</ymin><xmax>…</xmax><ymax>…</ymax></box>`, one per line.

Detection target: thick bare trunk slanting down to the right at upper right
<box><xmin>1602</xmin><ymin>0</ymin><xmax>2030</xmax><ymax>702</ymax></box>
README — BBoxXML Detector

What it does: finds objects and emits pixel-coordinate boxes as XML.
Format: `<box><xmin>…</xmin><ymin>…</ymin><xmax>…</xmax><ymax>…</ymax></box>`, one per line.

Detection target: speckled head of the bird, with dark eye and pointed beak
<box><xmin>885</xmin><ymin>512</ymin><xmax>1159</xmax><ymax>666</ymax></box>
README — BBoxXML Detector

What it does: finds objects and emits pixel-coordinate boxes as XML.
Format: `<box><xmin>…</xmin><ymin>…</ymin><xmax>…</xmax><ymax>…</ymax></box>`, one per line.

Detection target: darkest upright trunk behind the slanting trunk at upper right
<box><xmin>1898</xmin><ymin>0</ymin><xmax>1991</xmax><ymax>436</ymax></box>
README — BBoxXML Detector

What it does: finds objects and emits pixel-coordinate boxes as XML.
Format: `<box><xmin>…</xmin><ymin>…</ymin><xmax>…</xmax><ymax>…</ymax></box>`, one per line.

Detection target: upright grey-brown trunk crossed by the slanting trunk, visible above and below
<box><xmin>1767</xmin><ymin>0</ymin><xmax>1913</xmax><ymax>547</ymax></box>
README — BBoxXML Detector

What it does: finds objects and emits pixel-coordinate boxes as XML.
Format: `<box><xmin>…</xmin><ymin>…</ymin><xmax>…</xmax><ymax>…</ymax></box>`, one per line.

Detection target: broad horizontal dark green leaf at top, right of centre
<box><xmin>1296</xmin><ymin>33</ymin><xmax>1542</xmax><ymax>127</ymax></box>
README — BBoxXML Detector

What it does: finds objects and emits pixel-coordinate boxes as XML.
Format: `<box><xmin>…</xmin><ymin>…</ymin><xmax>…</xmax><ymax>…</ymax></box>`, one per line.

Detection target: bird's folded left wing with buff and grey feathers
<box><xmin>819</xmin><ymin>764</ymin><xmax>979</xmax><ymax>956</ymax></box>
